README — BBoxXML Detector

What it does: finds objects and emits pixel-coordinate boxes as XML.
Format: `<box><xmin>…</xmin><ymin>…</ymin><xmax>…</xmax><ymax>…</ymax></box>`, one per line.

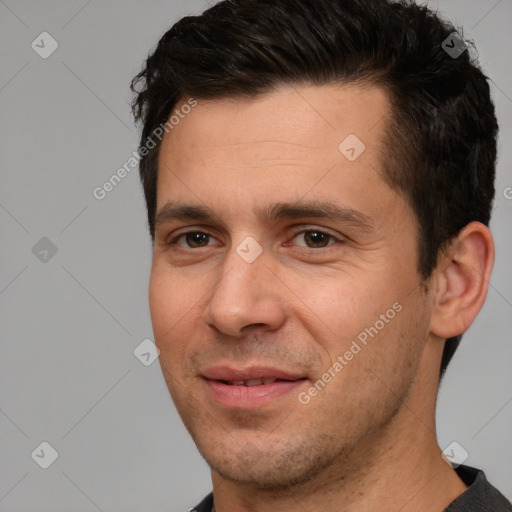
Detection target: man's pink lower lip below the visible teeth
<box><xmin>204</xmin><ymin>379</ymin><xmax>307</xmax><ymax>409</ymax></box>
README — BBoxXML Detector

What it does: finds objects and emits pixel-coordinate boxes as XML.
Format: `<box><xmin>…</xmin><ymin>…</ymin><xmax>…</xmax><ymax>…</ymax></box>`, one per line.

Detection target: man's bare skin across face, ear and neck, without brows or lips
<box><xmin>149</xmin><ymin>85</ymin><xmax>494</xmax><ymax>512</ymax></box>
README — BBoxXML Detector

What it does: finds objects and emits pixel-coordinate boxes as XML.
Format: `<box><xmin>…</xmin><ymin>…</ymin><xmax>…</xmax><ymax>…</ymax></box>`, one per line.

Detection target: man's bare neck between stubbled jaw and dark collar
<box><xmin>212</xmin><ymin>344</ymin><xmax>466</xmax><ymax>512</ymax></box>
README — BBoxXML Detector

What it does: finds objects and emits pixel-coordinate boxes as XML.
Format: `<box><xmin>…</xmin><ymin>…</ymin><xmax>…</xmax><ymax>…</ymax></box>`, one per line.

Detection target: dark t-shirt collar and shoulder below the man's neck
<box><xmin>190</xmin><ymin>466</ymin><xmax>512</xmax><ymax>512</ymax></box>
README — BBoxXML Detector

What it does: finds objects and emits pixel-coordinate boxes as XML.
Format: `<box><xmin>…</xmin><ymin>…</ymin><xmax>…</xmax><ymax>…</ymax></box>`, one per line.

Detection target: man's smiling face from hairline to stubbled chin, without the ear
<box><xmin>149</xmin><ymin>86</ymin><xmax>431</xmax><ymax>488</ymax></box>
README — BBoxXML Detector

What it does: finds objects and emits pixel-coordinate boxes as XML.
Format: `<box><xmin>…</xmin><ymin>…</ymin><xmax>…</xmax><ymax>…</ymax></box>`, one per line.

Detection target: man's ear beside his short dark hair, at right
<box><xmin>430</xmin><ymin>222</ymin><xmax>494</xmax><ymax>338</ymax></box>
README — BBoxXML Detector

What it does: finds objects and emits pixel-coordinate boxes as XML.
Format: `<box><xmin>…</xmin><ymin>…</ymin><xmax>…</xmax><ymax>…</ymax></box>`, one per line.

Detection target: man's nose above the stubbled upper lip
<box><xmin>204</xmin><ymin>242</ymin><xmax>286</xmax><ymax>337</ymax></box>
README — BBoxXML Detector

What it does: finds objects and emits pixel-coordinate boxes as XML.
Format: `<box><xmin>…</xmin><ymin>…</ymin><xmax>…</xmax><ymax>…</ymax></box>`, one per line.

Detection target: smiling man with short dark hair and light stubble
<box><xmin>132</xmin><ymin>0</ymin><xmax>512</xmax><ymax>512</ymax></box>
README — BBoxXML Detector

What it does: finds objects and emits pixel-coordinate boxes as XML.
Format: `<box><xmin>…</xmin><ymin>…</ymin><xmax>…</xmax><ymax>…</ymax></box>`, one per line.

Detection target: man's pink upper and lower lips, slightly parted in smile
<box><xmin>202</xmin><ymin>366</ymin><xmax>307</xmax><ymax>410</ymax></box>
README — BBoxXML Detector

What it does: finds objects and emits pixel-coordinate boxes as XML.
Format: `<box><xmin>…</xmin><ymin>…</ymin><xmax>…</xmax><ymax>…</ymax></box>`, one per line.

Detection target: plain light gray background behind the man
<box><xmin>0</xmin><ymin>0</ymin><xmax>512</xmax><ymax>512</ymax></box>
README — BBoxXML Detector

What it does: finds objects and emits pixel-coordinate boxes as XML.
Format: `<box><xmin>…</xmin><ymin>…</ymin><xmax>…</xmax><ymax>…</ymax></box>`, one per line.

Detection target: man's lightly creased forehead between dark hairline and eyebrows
<box><xmin>157</xmin><ymin>85</ymin><xmax>400</xmax><ymax>225</ymax></box>
